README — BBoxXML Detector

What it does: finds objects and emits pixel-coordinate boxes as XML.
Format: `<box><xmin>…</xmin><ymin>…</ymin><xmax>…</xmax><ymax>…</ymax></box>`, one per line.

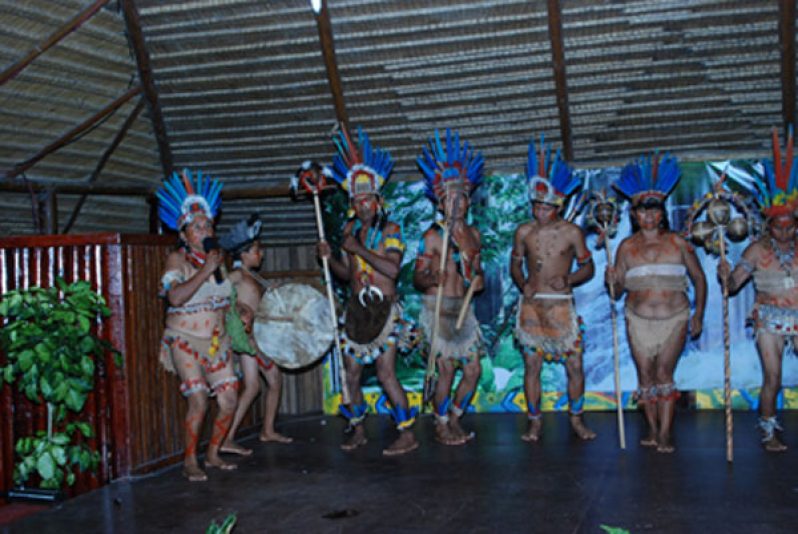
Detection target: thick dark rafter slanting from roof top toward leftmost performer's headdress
<box><xmin>122</xmin><ymin>0</ymin><xmax>174</xmax><ymax>180</ymax></box>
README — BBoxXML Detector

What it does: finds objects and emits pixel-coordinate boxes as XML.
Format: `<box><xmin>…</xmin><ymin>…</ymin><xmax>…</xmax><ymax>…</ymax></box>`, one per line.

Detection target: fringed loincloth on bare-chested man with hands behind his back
<box><xmin>515</xmin><ymin>293</ymin><xmax>584</xmax><ymax>363</ymax></box>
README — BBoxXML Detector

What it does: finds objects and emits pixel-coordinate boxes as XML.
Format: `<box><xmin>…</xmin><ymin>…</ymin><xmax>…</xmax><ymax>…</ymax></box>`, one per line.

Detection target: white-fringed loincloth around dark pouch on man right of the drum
<box><xmin>339</xmin><ymin>297</ymin><xmax>410</xmax><ymax>365</ymax></box>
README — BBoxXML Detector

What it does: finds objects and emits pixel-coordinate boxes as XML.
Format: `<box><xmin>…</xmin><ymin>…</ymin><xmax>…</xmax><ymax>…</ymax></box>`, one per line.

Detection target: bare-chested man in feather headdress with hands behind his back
<box><xmin>510</xmin><ymin>136</ymin><xmax>596</xmax><ymax>441</ymax></box>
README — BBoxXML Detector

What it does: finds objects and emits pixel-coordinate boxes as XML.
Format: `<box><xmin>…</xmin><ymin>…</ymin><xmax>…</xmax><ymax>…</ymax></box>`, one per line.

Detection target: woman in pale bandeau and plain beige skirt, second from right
<box><xmin>605</xmin><ymin>153</ymin><xmax>707</xmax><ymax>452</ymax></box>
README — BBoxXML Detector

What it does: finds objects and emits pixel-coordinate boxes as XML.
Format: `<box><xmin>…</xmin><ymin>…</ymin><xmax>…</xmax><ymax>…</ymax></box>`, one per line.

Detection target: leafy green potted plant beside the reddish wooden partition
<box><xmin>0</xmin><ymin>278</ymin><xmax>119</xmax><ymax>499</ymax></box>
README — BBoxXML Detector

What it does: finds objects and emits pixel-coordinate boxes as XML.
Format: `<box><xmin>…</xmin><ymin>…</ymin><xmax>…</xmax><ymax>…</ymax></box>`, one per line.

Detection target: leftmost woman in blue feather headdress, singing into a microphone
<box><xmin>157</xmin><ymin>170</ymin><xmax>242</xmax><ymax>481</ymax></box>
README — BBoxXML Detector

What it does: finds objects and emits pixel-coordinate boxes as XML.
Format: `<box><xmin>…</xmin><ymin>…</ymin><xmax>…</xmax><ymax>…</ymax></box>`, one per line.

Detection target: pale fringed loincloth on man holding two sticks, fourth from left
<box><xmin>418</xmin><ymin>295</ymin><xmax>483</xmax><ymax>363</ymax></box>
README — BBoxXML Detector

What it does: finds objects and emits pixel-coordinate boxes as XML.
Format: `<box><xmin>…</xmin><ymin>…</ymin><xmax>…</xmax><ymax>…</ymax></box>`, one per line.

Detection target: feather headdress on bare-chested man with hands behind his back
<box><xmin>526</xmin><ymin>135</ymin><xmax>582</xmax><ymax>207</ymax></box>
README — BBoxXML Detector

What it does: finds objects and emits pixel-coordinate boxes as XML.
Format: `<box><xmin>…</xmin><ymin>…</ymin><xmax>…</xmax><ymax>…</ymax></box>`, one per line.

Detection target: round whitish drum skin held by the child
<box><xmin>253</xmin><ymin>282</ymin><xmax>333</xmax><ymax>369</ymax></box>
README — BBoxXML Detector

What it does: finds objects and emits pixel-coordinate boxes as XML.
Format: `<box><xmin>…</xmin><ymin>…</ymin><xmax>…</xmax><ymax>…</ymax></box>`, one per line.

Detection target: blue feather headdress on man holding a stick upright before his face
<box><xmin>416</xmin><ymin>128</ymin><xmax>485</xmax><ymax>202</ymax></box>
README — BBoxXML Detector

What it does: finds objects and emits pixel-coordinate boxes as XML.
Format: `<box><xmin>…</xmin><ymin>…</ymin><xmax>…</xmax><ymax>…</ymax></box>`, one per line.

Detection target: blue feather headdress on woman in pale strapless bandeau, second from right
<box><xmin>613</xmin><ymin>152</ymin><xmax>681</xmax><ymax>206</ymax></box>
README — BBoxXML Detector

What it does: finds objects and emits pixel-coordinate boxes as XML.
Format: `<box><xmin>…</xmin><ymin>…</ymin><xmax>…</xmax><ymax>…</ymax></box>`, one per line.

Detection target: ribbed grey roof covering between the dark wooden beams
<box><xmin>0</xmin><ymin>0</ymin><xmax>782</xmax><ymax>243</ymax></box>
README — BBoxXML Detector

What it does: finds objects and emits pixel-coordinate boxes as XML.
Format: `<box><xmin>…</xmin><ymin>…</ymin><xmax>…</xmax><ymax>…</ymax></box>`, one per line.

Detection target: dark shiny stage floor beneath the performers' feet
<box><xmin>2</xmin><ymin>412</ymin><xmax>798</xmax><ymax>534</ymax></box>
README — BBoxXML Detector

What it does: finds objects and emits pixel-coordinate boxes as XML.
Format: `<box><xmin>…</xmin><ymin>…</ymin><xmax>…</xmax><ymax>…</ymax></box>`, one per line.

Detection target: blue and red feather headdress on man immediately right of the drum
<box><xmin>332</xmin><ymin>128</ymin><xmax>393</xmax><ymax>198</ymax></box>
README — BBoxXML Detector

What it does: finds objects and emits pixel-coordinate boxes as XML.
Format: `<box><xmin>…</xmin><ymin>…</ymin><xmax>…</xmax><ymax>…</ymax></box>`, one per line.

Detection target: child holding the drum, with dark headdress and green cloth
<box><xmin>219</xmin><ymin>214</ymin><xmax>293</xmax><ymax>456</ymax></box>
